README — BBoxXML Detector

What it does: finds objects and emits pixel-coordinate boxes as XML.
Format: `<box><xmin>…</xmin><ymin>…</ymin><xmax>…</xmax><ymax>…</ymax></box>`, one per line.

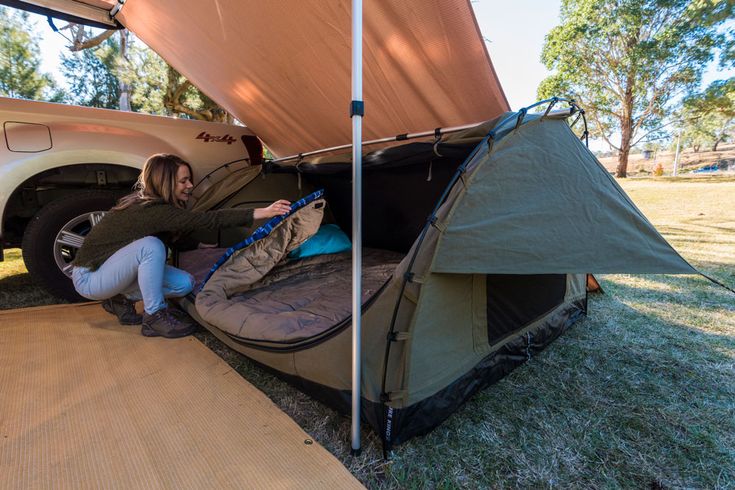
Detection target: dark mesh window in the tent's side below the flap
<box><xmin>487</xmin><ymin>274</ymin><xmax>567</xmax><ymax>345</ymax></box>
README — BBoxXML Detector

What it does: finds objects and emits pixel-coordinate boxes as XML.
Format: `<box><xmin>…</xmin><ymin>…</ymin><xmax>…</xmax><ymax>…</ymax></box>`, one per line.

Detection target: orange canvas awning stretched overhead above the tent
<box><xmin>10</xmin><ymin>0</ymin><xmax>509</xmax><ymax>156</ymax></box>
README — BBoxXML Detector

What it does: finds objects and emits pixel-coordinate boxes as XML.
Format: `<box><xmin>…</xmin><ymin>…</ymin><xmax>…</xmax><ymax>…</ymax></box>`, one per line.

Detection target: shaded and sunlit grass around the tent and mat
<box><xmin>0</xmin><ymin>177</ymin><xmax>735</xmax><ymax>489</ymax></box>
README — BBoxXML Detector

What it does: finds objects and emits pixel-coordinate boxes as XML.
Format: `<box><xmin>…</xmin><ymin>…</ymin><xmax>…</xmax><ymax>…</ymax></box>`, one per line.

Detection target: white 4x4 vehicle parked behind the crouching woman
<box><xmin>0</xmin><ymin>97</ymin><xmax>262</xmax><ymax>300</ymax></box>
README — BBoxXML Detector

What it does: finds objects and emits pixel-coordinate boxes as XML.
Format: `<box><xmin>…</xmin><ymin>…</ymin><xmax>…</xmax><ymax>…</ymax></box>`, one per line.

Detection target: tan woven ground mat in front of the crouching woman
<box><xmin>0</xmin><ymin>304</ymin><xmax>360</xmax><ymax>489</ymax></box>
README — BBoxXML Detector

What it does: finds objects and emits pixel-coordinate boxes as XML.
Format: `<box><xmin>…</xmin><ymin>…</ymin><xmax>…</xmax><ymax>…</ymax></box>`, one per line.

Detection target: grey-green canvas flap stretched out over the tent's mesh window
<box><xmin>432</xmin><ymin>119</ymin><xmax>696</xmax><ymax>274</ymax></box>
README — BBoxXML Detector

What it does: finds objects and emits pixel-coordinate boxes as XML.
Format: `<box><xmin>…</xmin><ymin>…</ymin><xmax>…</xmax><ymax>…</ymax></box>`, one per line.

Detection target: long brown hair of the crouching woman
<box><xmin>112</xmin><ymin>153</ymin><xmax>194</xmax><ymax>209</ymax></box>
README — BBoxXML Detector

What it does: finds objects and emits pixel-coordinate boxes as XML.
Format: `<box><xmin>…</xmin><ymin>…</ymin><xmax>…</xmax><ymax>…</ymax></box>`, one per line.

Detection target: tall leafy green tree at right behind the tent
<box><xmin>538</xmin><ymin>0</ymin><xmax>735</xmax><ymax>177</ymax></box>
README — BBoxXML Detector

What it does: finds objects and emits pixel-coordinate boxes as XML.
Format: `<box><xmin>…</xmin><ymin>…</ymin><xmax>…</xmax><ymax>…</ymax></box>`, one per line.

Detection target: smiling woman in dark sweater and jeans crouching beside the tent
<box><xmin>72</xmin><ymin>154</ymin><xmax>290</xmax><ymax>338</ymax></box>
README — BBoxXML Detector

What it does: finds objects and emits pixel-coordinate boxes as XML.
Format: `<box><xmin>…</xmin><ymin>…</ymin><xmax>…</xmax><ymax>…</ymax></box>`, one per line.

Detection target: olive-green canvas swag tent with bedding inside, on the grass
<box><xmin>180</xmin><ymin>106</ymin><xmax>695</xmax><ymax>447</ymax></box>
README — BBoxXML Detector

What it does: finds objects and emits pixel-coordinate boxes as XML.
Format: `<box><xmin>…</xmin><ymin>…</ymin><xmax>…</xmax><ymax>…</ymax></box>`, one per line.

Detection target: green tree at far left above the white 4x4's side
<box><xmin>0</xmin><ymin>7</ymin><xmax>64</xmax><ymax>102</ymax></box>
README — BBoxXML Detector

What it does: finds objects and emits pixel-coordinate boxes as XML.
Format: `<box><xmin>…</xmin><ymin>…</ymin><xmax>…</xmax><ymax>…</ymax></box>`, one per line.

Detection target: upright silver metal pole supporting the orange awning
<box><xmin>350</xmin><ymin>0</ymin><xmax>365</xmax><ymax>455</ymax></box>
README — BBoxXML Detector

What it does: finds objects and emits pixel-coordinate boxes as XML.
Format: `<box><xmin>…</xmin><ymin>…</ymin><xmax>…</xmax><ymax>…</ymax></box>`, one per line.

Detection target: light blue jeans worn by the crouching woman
<box><xmin>71</xmin><ymin>236</ymin><xmax>194</xmax><ymax>315</ymax></box>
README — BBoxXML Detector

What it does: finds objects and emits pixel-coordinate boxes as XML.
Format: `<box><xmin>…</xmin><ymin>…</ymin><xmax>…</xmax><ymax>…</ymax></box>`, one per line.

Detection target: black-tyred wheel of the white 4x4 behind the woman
<box><xmin>21</xmin><ymin>191</ymin><xmax>118</xmax><ymax>302</ymax></box>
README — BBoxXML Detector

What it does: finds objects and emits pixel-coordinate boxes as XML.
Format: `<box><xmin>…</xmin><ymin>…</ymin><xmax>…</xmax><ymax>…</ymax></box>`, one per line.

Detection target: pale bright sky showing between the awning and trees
<box><xmin>25</xmin><ymin>0</ymin><xmax>735</xmax><ymax>149</ymax></box>
